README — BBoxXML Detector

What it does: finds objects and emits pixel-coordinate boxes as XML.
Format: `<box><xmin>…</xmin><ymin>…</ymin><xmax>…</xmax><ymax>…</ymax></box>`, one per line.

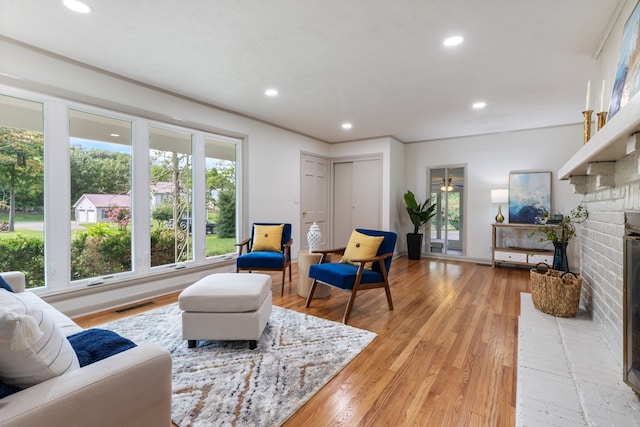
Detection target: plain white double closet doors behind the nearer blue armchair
<box><xmin>333</xmin><ymin>159</ymin><xmax>382</xmax><ymax>247</ymax></box>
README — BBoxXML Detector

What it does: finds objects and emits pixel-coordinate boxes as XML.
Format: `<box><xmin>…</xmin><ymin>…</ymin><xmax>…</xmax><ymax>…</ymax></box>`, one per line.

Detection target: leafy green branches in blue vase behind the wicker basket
<box><xmin>538</xmin><ymin>205</ymin><xmax>589</xmax><ymax>271</ymax></box>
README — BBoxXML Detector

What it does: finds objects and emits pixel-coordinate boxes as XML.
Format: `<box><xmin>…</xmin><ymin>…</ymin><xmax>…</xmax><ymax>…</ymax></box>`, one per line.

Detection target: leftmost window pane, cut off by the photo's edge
<box><xmin>0</xmin><ymin>95</ymin><xmax>45</xmax><ymax>287</ymax></box>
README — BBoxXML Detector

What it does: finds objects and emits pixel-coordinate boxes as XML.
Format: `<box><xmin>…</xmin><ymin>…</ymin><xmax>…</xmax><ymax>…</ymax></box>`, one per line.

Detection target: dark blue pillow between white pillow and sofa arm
<box><xmin>67</xmin><ymin>328</ymin><xmax>136</xmax><ymax>367</ymax></box>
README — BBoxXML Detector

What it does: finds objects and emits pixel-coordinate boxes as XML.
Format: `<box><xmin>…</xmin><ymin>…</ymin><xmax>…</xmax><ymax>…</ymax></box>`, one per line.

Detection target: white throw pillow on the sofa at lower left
<box><xmin>0</xmin><ymin>289</ymin><xmax>80</xmax><ymax>388</ymax></box>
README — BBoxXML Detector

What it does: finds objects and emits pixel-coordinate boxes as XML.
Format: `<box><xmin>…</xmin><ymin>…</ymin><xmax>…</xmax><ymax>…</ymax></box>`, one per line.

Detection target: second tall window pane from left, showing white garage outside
<box><xmin>69</xmin><ymin>110</ymin><xmax>133</xmax><ymax>281</ymax></box>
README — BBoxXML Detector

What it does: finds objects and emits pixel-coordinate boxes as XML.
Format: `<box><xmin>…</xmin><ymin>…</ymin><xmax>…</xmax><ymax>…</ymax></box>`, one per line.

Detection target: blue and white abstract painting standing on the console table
<box><xmin>509</xmin><ymin>172</ymin><xmax>551</xmax><ymax>224</ymax></box>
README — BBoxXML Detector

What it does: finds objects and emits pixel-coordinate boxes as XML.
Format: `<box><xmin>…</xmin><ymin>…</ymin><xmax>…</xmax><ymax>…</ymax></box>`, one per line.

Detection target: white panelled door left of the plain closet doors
<box><xmin>300</xmin><ymin>153</ymin><xmax>329</xmax><ymax>249</ymax></box>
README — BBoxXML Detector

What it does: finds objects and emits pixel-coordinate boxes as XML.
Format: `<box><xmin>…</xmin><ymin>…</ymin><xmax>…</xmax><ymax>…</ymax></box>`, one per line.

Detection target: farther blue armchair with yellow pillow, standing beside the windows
<box><xmin>236</xmin><ymin>222</ymin><xmax>293</xmax><ymax>295</ymax></box>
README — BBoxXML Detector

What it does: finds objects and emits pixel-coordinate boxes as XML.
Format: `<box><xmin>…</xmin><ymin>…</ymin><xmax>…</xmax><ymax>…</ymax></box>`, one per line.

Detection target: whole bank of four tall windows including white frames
<box><xmin>0</xmin><ymin>87</ymin><xmax>241</xmax><ymax>290</ymax></box>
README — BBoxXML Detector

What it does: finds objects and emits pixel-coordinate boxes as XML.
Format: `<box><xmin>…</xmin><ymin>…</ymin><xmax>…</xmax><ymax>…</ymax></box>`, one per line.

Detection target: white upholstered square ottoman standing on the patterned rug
<box><xmin>178</xmin><ymin>273</ymin><xmax>271</xmax><ymax>350</ymax></box>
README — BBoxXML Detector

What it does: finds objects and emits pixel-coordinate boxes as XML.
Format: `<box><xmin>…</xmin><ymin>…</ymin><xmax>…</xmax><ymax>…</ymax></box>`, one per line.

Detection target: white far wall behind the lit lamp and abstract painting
<box><xmin>405</xmin><ymin>123</ymin><xmax>582</xmax><ymax>269</ymax></box>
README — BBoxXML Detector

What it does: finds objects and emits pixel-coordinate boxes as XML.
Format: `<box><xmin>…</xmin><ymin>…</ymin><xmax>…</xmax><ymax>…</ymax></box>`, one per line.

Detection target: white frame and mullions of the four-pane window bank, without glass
<box><xmin>0</xmin><ymin>85</ymin><xmax>241</xmax><ymax>294</ymax></box>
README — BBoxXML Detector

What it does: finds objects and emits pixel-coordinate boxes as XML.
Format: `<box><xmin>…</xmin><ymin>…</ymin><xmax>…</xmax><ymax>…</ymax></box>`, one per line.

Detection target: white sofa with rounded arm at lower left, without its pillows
<box><xmin>0</xmin><ymin>272</ymin><xmax>171</xmax><ymax>427</ymax></box>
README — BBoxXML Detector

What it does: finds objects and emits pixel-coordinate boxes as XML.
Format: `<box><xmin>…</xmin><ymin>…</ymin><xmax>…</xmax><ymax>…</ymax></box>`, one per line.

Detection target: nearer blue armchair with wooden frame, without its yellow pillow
<box><xmin>306</xmin><ymin>228</ymin><xmax>398</xmax><ymax>324</ymax></box>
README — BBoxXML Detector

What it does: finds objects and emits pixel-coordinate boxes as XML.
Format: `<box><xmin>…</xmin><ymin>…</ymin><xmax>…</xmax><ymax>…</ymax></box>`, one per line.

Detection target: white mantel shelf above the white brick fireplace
<box><xmin>558</xmin><ymin>96</ymin><xmax>640</xmax><ymax>179</ymax></box>
